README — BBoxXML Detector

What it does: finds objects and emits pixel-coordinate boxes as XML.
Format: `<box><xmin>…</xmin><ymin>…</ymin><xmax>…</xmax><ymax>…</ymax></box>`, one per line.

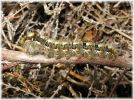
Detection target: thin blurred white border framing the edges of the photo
<box><xmin>0</xmin><ymin>0</ymin><xmax>134</xmax><ymax>100</ymax></box>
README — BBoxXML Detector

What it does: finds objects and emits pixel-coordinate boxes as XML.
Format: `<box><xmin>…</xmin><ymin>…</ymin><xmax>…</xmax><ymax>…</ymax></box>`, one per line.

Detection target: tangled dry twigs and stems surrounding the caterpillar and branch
<box><xmin>2</xmin><ymin>2</ymin><xmax>132</xmax><ymax>98</ymax></box>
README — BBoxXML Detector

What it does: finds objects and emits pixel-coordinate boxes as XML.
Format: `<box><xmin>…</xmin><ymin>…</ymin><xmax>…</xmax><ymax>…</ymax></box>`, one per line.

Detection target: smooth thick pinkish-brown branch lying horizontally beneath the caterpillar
<box><xmin>2</xmin><ymin>49</ymin><xmax>132</xmax><ymax>67</ymax></box>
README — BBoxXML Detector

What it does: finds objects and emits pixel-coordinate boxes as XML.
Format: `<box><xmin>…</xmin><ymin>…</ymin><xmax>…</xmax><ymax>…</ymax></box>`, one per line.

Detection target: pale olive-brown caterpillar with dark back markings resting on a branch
<box><xmin>24</xmin><ymin>32</ymin><xmax>116</xmax><ymax>59</ymax></box>
